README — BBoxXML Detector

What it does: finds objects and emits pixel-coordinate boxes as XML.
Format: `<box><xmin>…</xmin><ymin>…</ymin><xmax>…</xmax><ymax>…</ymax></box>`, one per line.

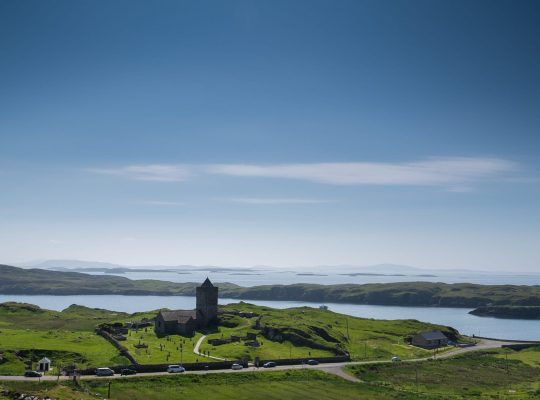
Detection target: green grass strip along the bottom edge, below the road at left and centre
<box><xmin>0</xmin><ymin>370</ymin><xmax>422</xmax><ymax>400</ymax></box>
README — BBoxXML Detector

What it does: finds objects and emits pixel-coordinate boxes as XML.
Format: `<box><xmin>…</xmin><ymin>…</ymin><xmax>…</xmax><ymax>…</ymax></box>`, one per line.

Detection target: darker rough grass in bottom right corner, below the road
<box><xmin>348</xmin><ymin>348</ymin><xmax>540</xmax><ymax>399</ymax></box>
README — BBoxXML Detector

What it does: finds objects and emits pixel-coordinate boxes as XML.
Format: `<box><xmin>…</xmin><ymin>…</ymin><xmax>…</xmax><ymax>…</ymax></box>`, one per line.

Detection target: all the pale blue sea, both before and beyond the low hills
<box><xmin>4</xmin><ymin>268</ymin><xmax>540</xmax><ymax>341</ymax></box>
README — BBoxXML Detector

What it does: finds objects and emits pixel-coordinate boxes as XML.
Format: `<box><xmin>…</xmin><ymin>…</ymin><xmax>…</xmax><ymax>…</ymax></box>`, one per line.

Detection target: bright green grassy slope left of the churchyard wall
<box><xmin>0</xmin><ymin>303</ymin><xmax>156</xmax><ymax>375</ymax></box>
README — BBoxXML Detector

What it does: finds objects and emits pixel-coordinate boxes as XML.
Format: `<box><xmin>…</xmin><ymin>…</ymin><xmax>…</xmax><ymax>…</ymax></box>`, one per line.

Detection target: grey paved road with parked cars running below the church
<box><xmin>0</xmin><ymin>337</ymin><xmax>516</xmax><ymax>382</ymax></box>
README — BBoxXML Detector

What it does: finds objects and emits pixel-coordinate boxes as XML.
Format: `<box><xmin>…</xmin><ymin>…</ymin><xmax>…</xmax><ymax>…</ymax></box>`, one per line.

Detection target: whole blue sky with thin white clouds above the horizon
<box><xmin>0</xmin><ymin>0</ymin><xmax>540</xmax><ymax>272</ymax></box>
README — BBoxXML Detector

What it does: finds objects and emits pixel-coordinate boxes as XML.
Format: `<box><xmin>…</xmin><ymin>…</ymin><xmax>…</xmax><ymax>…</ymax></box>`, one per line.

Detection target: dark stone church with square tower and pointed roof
<box><xmin>155</xmin><ymin>278</ymin><xmax>218</xmax><ymax>336</ymax></box>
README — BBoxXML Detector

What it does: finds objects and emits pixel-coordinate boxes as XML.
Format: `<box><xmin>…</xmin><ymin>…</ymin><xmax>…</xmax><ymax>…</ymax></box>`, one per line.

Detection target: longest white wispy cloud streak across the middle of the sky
<box><xmin>90</xmin><ymin>157</ymin><xmax>518</xmax><ymax>190</ymax></box>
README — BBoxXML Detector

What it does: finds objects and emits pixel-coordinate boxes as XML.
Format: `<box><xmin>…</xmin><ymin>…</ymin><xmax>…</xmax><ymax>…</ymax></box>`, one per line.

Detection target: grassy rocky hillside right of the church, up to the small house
<box><xmin>213</xmin><ymin>303</ymin><xmax>458</xmax><ymax>360</ymax></box>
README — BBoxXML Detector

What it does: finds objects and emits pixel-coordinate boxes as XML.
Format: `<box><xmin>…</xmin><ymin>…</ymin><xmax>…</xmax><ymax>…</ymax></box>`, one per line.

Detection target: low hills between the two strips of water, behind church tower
<box><xmin>0</xmin><ymin>265</ymin><xmax>540</xmax><ymax>308</ymax></box>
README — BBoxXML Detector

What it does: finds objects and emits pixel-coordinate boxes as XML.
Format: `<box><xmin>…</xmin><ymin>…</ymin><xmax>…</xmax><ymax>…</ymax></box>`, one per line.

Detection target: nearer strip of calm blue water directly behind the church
<box><xmin>0</xmin><ymin>295</ymin><xmax>540</xmax><ymax>340</ymax></box>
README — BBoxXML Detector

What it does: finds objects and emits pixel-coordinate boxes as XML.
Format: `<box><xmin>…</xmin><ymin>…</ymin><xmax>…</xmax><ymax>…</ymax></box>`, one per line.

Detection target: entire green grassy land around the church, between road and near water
<box><xmin>0</xmin><ymin>303</ymin><xmax>458</xmax><ymax>375</ymax></box>
